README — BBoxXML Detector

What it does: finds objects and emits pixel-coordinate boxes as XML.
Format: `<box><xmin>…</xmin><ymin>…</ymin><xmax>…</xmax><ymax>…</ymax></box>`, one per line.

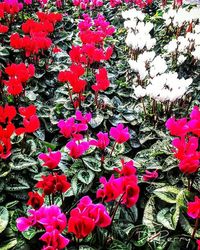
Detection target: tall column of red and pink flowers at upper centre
<box><xmin>58</xmin><ymin>14</ymin><xmax>115</xmax><ymax>107</ymax></box>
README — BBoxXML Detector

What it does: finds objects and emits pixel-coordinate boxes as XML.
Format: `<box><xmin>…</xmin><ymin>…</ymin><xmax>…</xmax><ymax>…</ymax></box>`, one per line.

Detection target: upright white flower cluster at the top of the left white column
<box><xmin>122</xmin><ymin>9</ymin><xmax>156</xmax><ymax>50</ymax></box>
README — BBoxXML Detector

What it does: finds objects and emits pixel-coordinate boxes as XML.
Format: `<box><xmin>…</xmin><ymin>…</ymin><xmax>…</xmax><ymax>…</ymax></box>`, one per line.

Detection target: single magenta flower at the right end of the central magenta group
<box><xmin>110</xmin><ymin>124</ymin><xmax>130</xmax><ymax>144</ymax></box>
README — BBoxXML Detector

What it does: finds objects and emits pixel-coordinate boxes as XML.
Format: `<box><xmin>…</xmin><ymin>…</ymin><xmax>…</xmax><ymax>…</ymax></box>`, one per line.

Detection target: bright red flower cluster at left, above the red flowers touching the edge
<box><xmin>3</xmin><ymin>63</ymin><xmax>35</xmax><ymax>95</ymax></box>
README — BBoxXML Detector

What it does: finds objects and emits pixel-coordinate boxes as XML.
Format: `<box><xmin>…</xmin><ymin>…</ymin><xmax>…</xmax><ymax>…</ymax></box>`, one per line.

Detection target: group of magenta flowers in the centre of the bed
<box><xmin>57</xmin><ymin>110</ymin><xmax>130</xmax><ymax>159</ymax></box>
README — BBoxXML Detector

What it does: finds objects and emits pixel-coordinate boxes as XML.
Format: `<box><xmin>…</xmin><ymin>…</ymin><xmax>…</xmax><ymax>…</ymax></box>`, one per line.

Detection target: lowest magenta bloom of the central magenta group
<box><xmin>66</xmin><ymin>140</ymin><xmax>89</xmax><ymax>159</ymax></box>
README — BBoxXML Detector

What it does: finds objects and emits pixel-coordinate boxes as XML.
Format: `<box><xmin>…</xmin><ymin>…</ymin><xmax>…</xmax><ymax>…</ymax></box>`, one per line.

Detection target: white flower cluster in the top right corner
<box><xmin>163</xmin><ymin>7</ymin><xmax>200</xmax><ymax>27</ymax></box>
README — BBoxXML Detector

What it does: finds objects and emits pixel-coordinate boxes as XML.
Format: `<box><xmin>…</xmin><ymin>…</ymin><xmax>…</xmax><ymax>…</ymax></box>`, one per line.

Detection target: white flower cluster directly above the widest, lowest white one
<box><xmin>129</xmin><ymin>51</ymin><xmax>167</xmax><ymax>80</ymax></box>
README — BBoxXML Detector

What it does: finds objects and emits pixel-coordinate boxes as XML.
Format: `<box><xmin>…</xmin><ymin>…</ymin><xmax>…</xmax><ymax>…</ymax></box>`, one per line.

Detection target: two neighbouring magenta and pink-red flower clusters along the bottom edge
<box><xmin>17</xmin><ymin>196</ymin><xmax>111</xmax><ymax>246</ymax></box>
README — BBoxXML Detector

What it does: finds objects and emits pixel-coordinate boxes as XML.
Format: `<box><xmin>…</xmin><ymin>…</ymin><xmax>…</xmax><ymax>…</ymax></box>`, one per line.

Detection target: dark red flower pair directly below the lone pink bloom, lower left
<box><xmin>36</xmin><ymin>173</ymin><xmax>71</xmax><ymax>195</ymax></box>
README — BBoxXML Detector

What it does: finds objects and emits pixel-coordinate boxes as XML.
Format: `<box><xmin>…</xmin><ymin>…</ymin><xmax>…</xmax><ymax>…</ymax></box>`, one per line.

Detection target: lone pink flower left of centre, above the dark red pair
<box><xmin>38</xmin><ymin>149</ymin><xmax>61</xmax><ymax>169</ymax></box>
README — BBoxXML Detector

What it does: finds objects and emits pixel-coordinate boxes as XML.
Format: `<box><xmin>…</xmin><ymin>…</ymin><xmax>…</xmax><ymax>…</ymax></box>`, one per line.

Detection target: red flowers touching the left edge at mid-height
<box><xmin>0</xmin><ymin>105</ymin><xmax>40</xmax><ymax>159</ymax></box>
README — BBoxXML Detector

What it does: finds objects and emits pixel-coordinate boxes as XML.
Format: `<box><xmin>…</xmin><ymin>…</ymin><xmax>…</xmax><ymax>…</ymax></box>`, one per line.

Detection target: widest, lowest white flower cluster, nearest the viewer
<box><xmin>134</xmin><ymin>73</ymin><xmax>192</xmax><ymax>102</ymax></box>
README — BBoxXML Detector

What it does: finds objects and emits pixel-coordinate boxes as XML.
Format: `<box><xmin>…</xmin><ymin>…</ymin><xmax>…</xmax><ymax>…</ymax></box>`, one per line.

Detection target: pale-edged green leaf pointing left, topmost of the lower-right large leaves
<box><xmin>153</xmin><ymin>186</ymin><xmax>180</xmax><ymax>204</ymax></box>
